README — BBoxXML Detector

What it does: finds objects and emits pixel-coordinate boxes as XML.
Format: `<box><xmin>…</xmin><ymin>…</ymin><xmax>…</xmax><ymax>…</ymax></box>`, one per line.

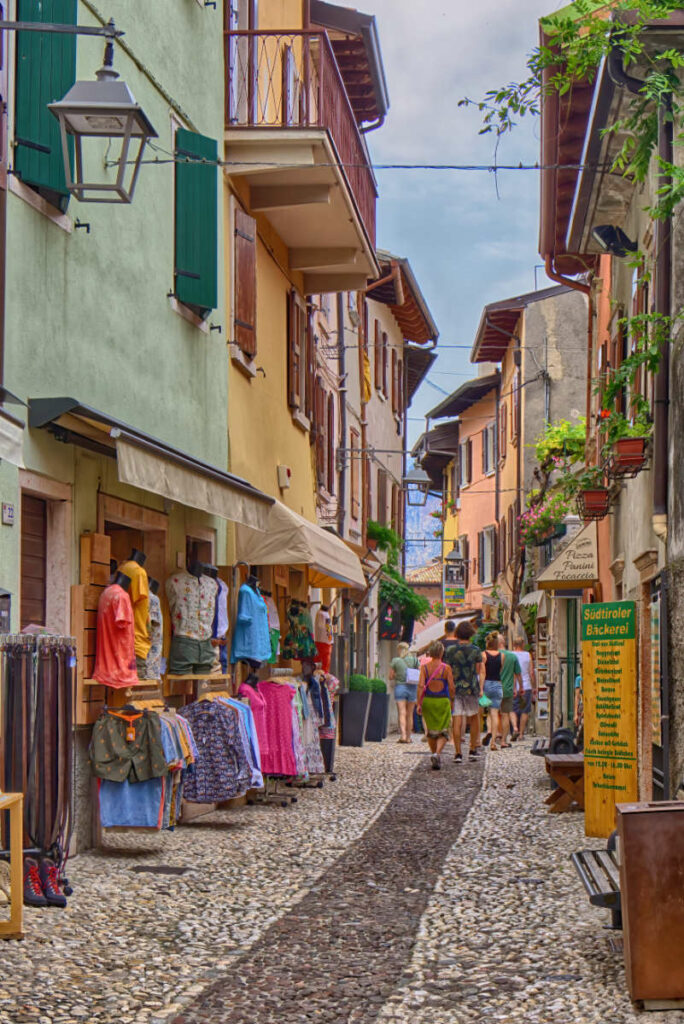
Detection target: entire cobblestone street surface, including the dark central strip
<box><xmin>0</xmin><ymin>741</ymin><xmax>681</xmax><ymax>1024</ymax></box>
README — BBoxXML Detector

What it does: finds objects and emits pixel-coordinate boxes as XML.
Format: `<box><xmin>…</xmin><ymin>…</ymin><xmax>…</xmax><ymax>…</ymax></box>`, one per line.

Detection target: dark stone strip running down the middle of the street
<box><xmin>168</xmin><ymin>757</ymin><xmax>484</xmax><ymax>1024</ymax></box>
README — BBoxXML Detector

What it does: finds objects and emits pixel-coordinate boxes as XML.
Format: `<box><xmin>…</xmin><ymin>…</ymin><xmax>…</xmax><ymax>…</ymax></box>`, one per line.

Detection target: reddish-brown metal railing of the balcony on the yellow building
<box><xmin>225</xmin><ymin>32</ymin><xmax>377</xmax><ymax>247</ymax></box>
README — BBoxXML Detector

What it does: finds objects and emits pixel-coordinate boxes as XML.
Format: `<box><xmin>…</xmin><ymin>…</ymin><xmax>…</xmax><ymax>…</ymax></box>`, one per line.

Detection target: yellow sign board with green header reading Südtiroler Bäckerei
<box><xmin>582</xmin><ymin>601</ymin><xmax>638</xmax><ymax>836</ymax></box>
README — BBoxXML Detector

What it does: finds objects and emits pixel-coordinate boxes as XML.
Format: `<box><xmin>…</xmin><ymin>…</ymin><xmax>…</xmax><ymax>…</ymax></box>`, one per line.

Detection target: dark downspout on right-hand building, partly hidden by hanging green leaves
<box><xmin>607</xmin><ymin>40</ymin><xmax>674</xmax><ymax>544</ymax></box>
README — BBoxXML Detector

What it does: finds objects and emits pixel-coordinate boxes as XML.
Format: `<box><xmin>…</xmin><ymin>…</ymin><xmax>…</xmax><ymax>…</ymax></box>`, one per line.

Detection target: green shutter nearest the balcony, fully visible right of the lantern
<box><xmin>174</xmin><ymin>128</ymin><xmax>218</xmax><ymax>313</ymax></box>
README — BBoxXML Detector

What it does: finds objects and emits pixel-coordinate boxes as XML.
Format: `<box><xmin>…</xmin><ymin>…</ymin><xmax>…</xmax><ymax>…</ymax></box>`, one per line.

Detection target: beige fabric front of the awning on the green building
<box><xmin>113</xmin><ymin>431</ymin><xmax>271</xmax><ymax>536</ymax></box>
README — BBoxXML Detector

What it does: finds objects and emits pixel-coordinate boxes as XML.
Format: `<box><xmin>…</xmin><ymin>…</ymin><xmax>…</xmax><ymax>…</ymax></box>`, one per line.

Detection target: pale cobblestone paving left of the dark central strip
<box><xmin>0</xmin><ymin>742</ymin><xmax>416</xmax><ymax>1024</ymax></box>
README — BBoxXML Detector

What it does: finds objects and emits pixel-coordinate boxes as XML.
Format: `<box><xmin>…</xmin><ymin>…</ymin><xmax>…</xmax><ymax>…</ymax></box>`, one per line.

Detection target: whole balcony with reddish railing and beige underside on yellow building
<box><xmin>225</xmin><ymin>31</ymin><xmax>378</xmax><ymax>293</ymax></box>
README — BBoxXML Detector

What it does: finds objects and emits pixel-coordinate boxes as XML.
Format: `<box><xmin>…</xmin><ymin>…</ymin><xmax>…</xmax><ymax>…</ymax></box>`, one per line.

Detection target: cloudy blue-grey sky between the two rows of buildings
<box><xmin>366</xmin><ymin>0</ymin><xmax>566</xmax><ymax>438</ymax></box>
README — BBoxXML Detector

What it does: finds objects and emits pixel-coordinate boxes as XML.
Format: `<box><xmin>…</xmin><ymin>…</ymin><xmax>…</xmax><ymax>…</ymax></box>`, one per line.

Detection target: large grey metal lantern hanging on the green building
<box><xmin>48</xmin><ymin>23</ymin><xmax>157</xmax><ymax>203</ymax></box>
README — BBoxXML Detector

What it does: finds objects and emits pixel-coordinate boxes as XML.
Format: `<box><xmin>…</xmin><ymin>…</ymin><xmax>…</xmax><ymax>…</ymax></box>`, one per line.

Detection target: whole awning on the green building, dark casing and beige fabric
<box><xmin>29</xmin><ymin>398</ymin><xmax>273</xmax><ymax>530</ymax></box>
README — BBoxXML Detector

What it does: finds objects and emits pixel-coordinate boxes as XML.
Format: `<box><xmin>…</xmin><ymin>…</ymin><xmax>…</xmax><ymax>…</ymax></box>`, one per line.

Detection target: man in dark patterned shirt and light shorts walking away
<box><xmin>444</xmin><ymin>623</ymin><xmax>484</xmax><ymax>764</ymax></box>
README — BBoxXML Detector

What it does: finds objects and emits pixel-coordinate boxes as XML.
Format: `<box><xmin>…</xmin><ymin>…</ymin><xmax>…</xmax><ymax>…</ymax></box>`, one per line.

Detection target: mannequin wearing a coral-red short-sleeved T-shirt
<box><xmin>92</xmin><ymin>569</ymin><xmax>138</xmax><ymax>689</ymax></box>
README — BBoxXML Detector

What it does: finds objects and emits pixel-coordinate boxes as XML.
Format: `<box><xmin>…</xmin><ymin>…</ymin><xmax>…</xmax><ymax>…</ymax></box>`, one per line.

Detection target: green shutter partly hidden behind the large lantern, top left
<box><xmin>14</xmin><ymin>0</ymin><xmax>75</xmax><ymax>210</ymax></box>
